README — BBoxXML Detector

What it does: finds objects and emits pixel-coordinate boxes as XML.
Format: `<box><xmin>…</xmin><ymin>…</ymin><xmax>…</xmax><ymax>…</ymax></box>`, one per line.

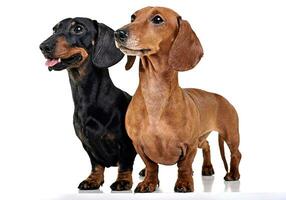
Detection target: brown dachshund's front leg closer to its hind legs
<box><xmin>174</xmin><ymin>147</ymin><xmax>197</xmax><ymax>192</ymax></box>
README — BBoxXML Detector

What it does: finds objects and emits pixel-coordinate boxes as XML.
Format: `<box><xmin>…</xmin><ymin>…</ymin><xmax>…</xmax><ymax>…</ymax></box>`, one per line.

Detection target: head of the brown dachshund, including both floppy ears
<box><xmin>115</xmin><ymin>7</ymin><xmax>203</xmax><ymax>71</ymax></box>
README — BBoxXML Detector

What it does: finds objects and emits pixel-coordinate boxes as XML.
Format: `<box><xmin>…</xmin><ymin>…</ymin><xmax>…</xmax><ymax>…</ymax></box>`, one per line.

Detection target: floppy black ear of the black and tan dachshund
<box><xmin>92</xmin><ymin>21</ymin><xmax>124</xmax><ymax>68</ymax></box>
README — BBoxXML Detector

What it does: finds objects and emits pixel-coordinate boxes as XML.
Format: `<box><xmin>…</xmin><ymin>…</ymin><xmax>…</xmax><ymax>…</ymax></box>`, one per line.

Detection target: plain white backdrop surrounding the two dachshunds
<box><xmin>0</xmin><ymin>0</ymin><xmax>286</xmax><ymax>200</ymax></box>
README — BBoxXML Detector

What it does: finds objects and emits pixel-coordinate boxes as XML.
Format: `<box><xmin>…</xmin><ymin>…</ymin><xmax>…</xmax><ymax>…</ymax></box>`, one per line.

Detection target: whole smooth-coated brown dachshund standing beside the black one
<box><xmin>115</xmin><ymin>7</ymin><xmax>241</xmax><ymax>192</ymax></box>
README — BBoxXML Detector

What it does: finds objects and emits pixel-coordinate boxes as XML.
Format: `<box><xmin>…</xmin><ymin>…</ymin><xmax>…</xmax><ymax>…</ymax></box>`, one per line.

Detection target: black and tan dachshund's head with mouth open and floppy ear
<box><xmin>40</xmin><ymin>18</ymin><xmax>123</xmax><ymax>71</ymax></box>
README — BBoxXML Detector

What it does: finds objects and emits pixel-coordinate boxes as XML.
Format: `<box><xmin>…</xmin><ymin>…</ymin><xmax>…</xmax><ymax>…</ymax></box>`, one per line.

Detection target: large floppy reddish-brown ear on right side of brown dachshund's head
<box><xmin>168</xmin><ymin>18</ymin><xmax>204</xmax><ymax>71</ymax></box>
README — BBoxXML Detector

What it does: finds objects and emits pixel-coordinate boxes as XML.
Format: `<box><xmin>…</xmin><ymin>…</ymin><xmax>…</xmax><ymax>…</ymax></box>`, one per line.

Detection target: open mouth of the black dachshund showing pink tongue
<box><xmin>46</xmin><ymin>53</ymin><xmax>82</xmax><ymax>71</ymax></box>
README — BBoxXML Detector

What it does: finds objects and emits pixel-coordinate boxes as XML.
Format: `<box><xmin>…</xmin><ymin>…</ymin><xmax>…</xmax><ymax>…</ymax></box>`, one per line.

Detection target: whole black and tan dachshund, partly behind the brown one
<box><xmin>40</xmin><ymin>18</ymin><xmax>136</xmax><ymax>190</ymax></box>
